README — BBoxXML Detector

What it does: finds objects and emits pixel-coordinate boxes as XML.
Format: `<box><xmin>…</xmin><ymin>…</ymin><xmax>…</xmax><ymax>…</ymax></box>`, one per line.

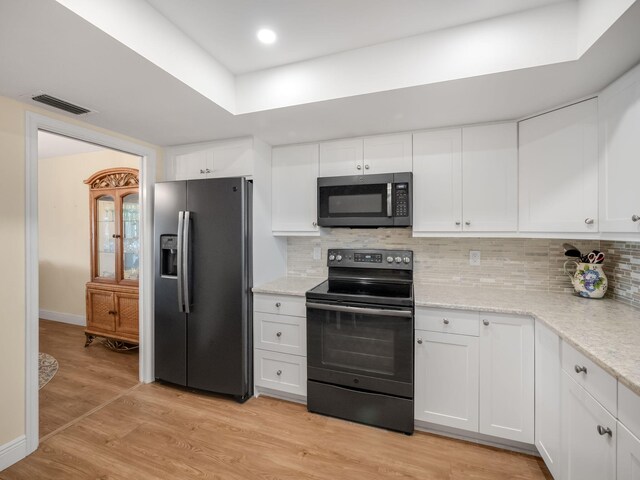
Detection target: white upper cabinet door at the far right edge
<box><xmin>599</xmin><ymin>68</ymin><xmax>640</xmax><ymax>233</ymax></box>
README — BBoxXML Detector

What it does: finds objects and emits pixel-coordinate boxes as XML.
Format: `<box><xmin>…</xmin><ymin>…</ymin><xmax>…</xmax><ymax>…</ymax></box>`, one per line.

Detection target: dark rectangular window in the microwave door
<box><xmin>319</xmin><ymin>183</ymin><xmax>388</xmax><ymax>218</ymax></box>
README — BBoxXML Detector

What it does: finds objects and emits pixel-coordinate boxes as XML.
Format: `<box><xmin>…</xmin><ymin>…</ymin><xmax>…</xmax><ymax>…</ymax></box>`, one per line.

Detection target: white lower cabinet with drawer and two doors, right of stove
<box><xmin>415</xmin><ymin>308</ymin><xmax>534</xmax><ymax>444</ymax></box>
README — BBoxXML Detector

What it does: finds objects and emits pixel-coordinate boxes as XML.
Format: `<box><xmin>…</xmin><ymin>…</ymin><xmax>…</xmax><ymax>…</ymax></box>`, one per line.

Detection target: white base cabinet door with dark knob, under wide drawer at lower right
<box><xmin>561</xmin><ymin>372</ymin><xmax>617</xmax><ymax>480</ymax></box>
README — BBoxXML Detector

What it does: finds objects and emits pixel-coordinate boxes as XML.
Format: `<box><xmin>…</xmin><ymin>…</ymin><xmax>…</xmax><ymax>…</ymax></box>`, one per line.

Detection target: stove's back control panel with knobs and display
<box><xmin>327</xmin><ymin>248</ymin><xmax>413</xmax><ymax>270</ymax></box>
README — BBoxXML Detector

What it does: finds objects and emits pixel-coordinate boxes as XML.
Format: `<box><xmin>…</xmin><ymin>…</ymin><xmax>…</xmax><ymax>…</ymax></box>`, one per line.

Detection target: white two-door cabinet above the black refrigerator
<box><xmin>166</xmin><ymin>138</ymin><xmax>254</xmax><ymax>180</ymax></box>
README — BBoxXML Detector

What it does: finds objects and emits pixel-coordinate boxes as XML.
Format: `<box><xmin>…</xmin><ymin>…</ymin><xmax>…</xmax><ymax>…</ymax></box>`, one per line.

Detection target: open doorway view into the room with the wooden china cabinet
<box><xmin>38</xmin><ymin>130</ymin><xmax>140</xmax><ymax>441</ymax></box>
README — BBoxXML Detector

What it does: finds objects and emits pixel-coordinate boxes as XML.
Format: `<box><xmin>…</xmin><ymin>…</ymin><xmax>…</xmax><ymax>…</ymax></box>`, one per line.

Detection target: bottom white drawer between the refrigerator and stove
<box><xmin>254</xmin><ymin>349</ymin><xmax>307</xmax><ymax>396</ymax></box>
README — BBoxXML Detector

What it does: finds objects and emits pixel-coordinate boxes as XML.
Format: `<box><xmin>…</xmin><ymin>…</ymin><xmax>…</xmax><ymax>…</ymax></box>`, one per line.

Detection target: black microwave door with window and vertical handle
<box><xmin>318</xmin><ymin>175</ymin><xmax>394</xmax><ymax>227</ymax></box>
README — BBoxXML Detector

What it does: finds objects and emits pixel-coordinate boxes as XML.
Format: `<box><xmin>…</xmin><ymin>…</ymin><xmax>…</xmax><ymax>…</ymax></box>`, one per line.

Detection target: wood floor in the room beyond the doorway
<box><xmin>39</xmin><ymin>320</ymin><xmax>138</xmax><ymax>438</ymax></box>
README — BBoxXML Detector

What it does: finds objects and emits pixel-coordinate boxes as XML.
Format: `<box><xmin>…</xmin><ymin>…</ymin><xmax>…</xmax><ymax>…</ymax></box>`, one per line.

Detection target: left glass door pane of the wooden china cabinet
<box><xmin>96</xmin><ymin>195</ymin><xmax>116</xmax><ymax>279</ymax></box>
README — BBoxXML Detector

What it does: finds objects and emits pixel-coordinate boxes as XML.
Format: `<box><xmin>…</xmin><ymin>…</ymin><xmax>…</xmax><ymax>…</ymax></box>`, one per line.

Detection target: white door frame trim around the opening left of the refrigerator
<box><xmin>25</xmin><ymin>112</ymin><xmax>156</xmax><ymax>455</ymax></box>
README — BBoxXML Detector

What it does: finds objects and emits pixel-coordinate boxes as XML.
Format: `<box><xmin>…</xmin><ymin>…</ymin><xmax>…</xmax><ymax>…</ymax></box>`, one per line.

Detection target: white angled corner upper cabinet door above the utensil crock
<box><xmin>519</xmin><ymin>99</ymin><xmax>598</xmax><ymax>232</ymax></box>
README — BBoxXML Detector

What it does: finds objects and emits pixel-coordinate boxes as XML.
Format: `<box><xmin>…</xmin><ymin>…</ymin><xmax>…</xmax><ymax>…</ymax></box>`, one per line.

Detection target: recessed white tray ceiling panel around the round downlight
<box><xmin>146</xmin><ymin>0</ymin><xmax>566</xmax><ymax>74</ymax></box>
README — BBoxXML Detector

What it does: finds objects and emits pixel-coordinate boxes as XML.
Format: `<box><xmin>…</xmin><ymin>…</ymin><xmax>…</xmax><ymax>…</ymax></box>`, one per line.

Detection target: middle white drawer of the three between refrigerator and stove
<box><xmin>253</xmin><ymin>312</ymin><xmax>307</xmax><ymax>355</ymax></box>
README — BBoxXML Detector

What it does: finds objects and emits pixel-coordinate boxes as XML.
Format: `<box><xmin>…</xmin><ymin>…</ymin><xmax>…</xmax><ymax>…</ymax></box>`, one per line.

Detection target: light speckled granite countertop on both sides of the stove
<box><xmin>253</xmin><ymin>277</ymin><xmax>640</xmax><ymax>395</ymax></box>
